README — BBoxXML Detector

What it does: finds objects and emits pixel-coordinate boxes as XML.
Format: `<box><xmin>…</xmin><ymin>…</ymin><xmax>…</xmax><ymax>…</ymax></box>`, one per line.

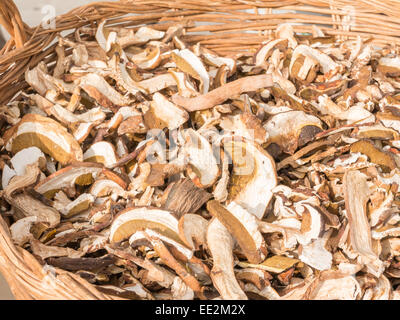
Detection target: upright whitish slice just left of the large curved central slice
<box><xmin>182</xmin><ymin>129</ymin><xmax>220</xmax><ymax>188</ymax></box>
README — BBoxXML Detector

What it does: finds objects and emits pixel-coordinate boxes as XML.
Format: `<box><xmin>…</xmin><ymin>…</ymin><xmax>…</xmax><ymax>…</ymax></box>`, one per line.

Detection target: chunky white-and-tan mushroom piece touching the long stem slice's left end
<box><xmin>144</xmin><ymin>92</ymin><xmax>189</xmax><ymax>130</ymax></box>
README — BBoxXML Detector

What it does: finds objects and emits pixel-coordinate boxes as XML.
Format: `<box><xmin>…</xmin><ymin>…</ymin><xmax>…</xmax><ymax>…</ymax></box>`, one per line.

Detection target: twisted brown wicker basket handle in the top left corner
<box><xmin>0</xmin><ymin>0</ymin><xmax>27</xmax><ymax>49</ymax></box>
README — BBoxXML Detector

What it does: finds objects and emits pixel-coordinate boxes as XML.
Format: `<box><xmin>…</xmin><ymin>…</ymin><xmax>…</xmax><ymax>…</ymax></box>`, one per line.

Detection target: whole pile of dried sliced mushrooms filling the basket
<box><xmin>0</xmin><ymin>21</ymin><xmax>400</xmax><ymax>300</ymax></box>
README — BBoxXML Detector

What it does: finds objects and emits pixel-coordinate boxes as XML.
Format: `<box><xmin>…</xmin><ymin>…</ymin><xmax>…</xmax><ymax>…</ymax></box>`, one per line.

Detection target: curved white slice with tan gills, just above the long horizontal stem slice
<box><xmin>172</xmin><ymin>49</ymin><xmax>210</xmax><ymax>94</ymax></box>
